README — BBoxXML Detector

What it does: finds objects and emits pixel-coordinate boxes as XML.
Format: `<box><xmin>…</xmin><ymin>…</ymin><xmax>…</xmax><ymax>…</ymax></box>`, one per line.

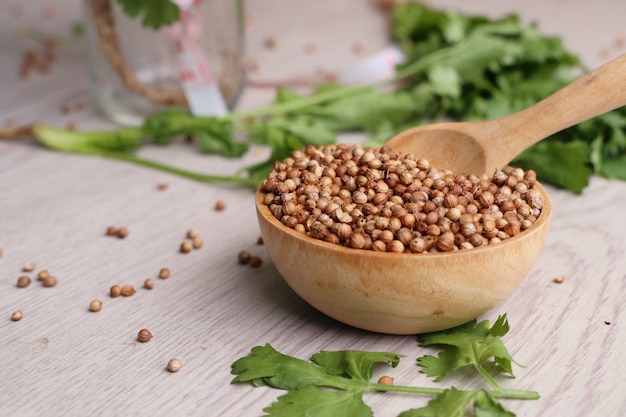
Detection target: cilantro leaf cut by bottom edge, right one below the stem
<box><xmin>398</xmin><ymin>387</ymin><xmax>515</xmax><ymax>417</ymax></box>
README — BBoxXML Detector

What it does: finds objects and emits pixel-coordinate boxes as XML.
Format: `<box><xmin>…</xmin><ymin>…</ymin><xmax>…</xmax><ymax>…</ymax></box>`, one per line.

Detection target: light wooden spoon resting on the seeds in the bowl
<box><xmin>386</xmin><ymin>54</ymin><xmax>626</xmax><ymax>174</ymax></box>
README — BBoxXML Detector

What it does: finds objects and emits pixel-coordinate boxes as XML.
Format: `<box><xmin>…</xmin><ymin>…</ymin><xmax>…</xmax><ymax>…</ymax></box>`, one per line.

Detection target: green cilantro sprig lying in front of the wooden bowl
<box><xmin>231</xmin><ymin>315</ymin><xmax>539</xmax><ymax>417</ymax></box>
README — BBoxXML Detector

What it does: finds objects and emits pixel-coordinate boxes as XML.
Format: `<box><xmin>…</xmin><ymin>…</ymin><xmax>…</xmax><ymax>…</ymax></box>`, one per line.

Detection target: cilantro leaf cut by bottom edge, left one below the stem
<box><xmin>263</xmin><ymin>386</ymin><xmax>373</xmax><ymax>417</ymax></box>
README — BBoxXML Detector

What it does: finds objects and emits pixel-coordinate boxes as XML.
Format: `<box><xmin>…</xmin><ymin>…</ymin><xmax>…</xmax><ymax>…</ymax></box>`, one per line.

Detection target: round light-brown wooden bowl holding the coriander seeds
<box><xmin>256</xmin><ymin>184</ymin><xmax>552</xmax><ymax>334</ymax></box>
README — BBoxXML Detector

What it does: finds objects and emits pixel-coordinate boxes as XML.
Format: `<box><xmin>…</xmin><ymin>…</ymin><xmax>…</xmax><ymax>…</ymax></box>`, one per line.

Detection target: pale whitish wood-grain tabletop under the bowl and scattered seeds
<box><xmin>0</xmin><ymin>0</ymin><xmax>626</xmax><ymax>417</ymax></box>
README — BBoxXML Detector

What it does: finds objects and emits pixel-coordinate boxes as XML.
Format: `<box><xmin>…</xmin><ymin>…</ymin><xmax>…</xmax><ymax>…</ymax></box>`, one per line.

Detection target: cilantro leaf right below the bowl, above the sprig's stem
<box><xmin>417</xmin><ymin>315</ymin><xmax>513</xmax><ymax>382</ymax></box>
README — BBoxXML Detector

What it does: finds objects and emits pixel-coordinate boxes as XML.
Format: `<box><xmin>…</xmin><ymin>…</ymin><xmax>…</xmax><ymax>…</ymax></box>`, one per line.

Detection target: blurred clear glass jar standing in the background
<box><xmin>83</xmin><ymin>0</ymin><xmax>245</xmax><ymax>126</ymax></box>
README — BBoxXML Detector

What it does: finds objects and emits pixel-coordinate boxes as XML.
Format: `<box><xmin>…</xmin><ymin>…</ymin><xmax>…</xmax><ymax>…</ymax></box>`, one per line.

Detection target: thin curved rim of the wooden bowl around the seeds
<box><xmin>255</xmin><ymin>182</ymin><xmax>552</xmax><ymax>259</ymax></box>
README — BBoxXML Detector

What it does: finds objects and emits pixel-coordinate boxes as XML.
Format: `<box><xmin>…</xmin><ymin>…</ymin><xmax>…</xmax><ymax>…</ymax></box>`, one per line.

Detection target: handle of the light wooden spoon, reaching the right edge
<box><xmin>492</xmin><ymin>54</ymin><xmax>626</xmax><ymax>166</ymax></box>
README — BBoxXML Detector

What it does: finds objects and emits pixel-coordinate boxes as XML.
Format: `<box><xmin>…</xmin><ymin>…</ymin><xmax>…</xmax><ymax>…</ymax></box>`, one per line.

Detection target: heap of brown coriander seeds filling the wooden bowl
<box><xmin>260</xmin><ymin>144</ymin><xmax>543</xmax><ymax>253</ymax></box>
